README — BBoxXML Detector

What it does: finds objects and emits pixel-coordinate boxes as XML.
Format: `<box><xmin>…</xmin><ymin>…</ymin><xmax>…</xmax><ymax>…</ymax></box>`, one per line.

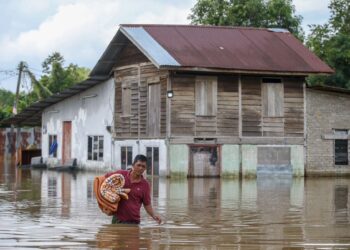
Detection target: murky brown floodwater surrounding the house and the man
<box><xmin>0</xmin><ymin>159</ymin><xmax>350</xmax><ymax>249</ymax></box>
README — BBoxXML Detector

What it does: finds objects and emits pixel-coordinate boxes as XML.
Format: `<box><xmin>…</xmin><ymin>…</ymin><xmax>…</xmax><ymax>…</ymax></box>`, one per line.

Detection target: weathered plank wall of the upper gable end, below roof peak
<box><xmin>114</xmin><ymin>63</ymin><xmax>167</xmax><ymax>138</ymax></box>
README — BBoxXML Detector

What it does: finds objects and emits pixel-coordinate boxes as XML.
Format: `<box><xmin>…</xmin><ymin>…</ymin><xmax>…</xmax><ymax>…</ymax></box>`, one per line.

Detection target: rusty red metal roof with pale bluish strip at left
<box><xmin>121</xmin><ymin>24</ymin><xmax>333</xmax><ymax>74</ymax></box>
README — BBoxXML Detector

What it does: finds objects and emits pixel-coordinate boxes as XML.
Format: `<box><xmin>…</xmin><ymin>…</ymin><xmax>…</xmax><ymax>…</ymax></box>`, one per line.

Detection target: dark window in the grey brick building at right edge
<box><xmin>334</xmin><ymin>129</ymin><xmax>349</xmax><ymax>165</ymax></box>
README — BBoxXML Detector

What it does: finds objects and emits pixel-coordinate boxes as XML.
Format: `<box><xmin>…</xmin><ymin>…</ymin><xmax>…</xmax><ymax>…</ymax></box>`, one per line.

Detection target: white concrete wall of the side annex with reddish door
<box><xmin>42</xmin><ymin>79</ymin><xmax>115</xmax><ymax>169</ymax></box>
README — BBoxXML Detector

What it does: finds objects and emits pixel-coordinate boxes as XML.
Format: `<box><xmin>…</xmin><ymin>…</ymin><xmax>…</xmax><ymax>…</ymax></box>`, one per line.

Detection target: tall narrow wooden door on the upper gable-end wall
<box><xmin>147</xmin><ymin>83</ymin><xmax>160</xmax><ymax>137</ymax></box>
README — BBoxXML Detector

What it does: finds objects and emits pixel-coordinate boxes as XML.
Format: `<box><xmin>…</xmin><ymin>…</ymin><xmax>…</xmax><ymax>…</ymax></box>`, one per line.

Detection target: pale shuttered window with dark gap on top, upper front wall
<box><xmin>261</xmin><ymin>78</ymin><xmax>284</xmax><ymax>117</ymax></box>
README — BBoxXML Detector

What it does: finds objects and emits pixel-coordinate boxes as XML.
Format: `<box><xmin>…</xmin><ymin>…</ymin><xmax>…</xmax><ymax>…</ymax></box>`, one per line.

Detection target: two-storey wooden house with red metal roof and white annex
<box><xmin>0</xmin><ymin>25</ymin><xmax>333</xmax><ymax>177</ymax></box>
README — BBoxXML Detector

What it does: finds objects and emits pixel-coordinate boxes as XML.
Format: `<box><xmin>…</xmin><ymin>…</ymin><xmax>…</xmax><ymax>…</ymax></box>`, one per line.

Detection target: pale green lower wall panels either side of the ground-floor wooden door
<box><xmin>169</xmin><ymin>144</ymin><xmax>304</xmax><ymax>178</ymax></box>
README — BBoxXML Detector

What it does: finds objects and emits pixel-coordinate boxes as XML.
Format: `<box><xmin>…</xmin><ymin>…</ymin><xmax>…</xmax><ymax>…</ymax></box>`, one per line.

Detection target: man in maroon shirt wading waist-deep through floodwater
<box><xmin>105</xmin><ymin>155</ymin><xmax>162</xmax><ymax>224</ymax></box>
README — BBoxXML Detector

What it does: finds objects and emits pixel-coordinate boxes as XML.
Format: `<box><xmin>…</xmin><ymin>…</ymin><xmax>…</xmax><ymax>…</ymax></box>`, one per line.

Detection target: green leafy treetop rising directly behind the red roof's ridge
<box><xmin>188</xmin><ymin>0</ymin><xmax>304</xmax><ymax>40</ymax></box>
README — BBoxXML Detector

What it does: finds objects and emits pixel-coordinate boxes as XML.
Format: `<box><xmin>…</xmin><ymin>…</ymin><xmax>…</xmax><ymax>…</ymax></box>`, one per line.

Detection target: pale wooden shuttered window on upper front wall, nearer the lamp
<box><xmin>196</xmin><ymin>76</ymin><xmax>217</xmax><ymax>116</ymax></box>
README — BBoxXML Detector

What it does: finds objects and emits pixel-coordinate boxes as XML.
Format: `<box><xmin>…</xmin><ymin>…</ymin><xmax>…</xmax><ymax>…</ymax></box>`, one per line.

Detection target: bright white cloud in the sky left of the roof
<box><xmin>0</xmin><ymin>0</ymin><xmax>194</xmax><ymax>92</ymax></box>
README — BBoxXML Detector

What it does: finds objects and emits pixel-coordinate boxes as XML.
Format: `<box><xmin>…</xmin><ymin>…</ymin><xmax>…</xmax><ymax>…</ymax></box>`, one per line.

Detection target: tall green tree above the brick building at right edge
<box><xmin>306</xmin><ymin>0</ymin><xmax>350</xmax><ymax>89</ymax></box>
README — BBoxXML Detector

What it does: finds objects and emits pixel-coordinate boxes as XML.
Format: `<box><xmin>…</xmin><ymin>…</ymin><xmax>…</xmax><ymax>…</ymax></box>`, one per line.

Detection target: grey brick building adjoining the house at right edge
<box><xmin>305</xmin><ymin>87</ymin><xmax>350</xmax><ymax>176</ymax></box>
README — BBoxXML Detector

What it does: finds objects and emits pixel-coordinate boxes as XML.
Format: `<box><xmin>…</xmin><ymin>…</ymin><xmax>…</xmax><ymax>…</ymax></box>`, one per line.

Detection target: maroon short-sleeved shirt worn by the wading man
<box><xmin>105</xmin><ymin>170</ymin><xmax>151</xmax><ymax>223</ymax></box>
